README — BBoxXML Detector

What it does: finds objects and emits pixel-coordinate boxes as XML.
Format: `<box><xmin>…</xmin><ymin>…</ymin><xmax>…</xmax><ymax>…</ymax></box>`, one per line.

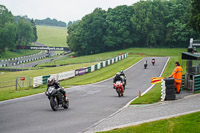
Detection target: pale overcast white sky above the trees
<box><xmin>0</xmin><ymin>0</ymin><xmax>139</xmax><ymax>23</ymax></box>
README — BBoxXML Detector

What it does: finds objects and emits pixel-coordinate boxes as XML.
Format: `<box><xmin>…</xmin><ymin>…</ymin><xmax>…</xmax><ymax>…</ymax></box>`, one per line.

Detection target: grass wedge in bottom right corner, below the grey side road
<box><xmin>99</xmin><ymin>112</ymin><xmax>200</xmax><ymax>133</ymax></box>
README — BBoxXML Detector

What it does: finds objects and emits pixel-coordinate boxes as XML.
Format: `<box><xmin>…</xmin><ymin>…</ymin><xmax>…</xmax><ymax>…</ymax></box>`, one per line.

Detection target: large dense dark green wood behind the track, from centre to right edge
<box><xmin>67</xmin><ymin>0</ymin><xmax>200</xmax><ymax>55</ymax></box>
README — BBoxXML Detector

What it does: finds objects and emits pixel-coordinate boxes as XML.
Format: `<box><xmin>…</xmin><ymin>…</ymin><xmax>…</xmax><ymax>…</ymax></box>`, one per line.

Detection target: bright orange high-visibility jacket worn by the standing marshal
<box><xmin>170</xmin><ymin>66</ymin><xmax>183</xmax><ymax>83</ymax></box>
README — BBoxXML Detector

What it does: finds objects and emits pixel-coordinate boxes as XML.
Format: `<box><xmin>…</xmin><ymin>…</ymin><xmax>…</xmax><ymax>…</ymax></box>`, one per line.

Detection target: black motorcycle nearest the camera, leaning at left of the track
<box><xmin>45</xmin><ymin>86</ymin><xmax>69</xmax><ymax>111</ymax></box>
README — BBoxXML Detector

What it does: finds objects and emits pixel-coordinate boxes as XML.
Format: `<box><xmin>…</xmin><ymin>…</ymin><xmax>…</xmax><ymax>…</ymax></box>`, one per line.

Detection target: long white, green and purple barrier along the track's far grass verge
<box><xmin>33</xmin><ymin>53</ymin><xmax>128</xmax><ymax>87</ymax></box>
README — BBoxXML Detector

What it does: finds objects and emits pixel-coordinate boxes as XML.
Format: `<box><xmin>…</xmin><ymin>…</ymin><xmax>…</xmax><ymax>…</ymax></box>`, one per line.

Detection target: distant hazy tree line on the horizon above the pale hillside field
<box><xmin>35</xmin><ymin>18</ymin><xmax>66</xmax><ymax>27</ymax></box>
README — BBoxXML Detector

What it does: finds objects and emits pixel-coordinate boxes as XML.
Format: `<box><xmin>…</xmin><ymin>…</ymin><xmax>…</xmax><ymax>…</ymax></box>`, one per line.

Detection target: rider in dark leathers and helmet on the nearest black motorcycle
<box><xmin>47</xmin><ymin>77</ymin><xmax>66</xmax><ymax>99</ymax></box>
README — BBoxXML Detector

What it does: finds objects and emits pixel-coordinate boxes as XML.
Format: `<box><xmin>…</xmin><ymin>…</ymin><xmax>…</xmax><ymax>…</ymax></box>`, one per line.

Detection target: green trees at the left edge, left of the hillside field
<box><xmin>0</xmin><ymin>5</ymin><xmax>37</xmax><ymax>54</ymax></box>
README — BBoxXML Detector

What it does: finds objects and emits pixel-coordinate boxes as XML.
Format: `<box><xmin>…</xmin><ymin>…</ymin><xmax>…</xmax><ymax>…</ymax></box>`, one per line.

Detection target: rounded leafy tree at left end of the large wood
<box><xmin>67</xmin><ymin>8</ymin><xmax>106</xmax><ymax>55</ymax></box>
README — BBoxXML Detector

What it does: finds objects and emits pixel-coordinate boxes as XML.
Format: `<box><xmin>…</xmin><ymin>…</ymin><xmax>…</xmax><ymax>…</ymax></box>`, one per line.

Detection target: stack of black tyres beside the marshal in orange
<box><xmin>164</xmin><ymin>78</ymin><xmax>176</xmax><ymax>100</ymax></box>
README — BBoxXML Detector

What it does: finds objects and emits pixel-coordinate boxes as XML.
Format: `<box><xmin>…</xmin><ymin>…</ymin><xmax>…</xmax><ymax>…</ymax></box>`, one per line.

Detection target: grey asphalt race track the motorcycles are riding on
<box><xmin>0</xmin><ymin>57</ymin><xmax>168</xmax><ymax>133</ymax></box>
